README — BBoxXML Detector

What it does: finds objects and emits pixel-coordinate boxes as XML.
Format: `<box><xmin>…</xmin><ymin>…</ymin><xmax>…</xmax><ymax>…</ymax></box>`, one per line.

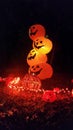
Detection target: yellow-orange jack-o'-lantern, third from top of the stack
<box><xmin>27</xmin><ymin>49</ymin><xmax>47</xmax><ymax>66</ymax></box>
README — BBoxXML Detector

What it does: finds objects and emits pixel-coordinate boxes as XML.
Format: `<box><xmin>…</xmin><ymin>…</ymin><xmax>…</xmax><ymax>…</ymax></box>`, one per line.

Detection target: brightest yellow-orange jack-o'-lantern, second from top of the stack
<box><xmin>32</xmin><ymin>37</ymin><xmax>53</xmax><ymax>54</ymax></box>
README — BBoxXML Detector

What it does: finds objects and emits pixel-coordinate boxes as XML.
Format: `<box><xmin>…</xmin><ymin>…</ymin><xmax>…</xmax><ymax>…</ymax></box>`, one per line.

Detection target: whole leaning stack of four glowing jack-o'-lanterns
<box><xmin>27</xmin><ymin>24</ymin><xmax>53</xmax><ymax>80</ymax></box>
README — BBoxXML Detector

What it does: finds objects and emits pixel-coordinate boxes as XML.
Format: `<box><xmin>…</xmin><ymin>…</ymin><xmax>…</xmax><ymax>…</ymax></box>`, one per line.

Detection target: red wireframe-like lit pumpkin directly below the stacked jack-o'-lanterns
<box><xmin>22</xmin><ymin>74</ymin><xmax>41</xmax><ymax>90</ymax></box>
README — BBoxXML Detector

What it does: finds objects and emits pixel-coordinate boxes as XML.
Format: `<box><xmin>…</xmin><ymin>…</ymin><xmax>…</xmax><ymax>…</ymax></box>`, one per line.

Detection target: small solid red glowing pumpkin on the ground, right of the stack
<box><xmin>42</xmin><ymin>90</ymin><xmax>57</xmax><ymax>102</ymax></box>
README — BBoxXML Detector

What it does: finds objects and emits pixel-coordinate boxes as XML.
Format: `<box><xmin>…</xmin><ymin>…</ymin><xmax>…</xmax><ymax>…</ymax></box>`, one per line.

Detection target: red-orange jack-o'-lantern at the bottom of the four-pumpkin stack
<box><xmin>28</xmin><ymin>63</ymin><xmax>53</xmax><ymax>80</ymax></box>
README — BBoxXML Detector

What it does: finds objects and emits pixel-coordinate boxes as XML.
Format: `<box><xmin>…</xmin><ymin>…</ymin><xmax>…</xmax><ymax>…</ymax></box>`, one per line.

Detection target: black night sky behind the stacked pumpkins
<box><xmin>0</xmin><ymin>0</ymin><xmax>73</xmax><ymax>73</ymax></box>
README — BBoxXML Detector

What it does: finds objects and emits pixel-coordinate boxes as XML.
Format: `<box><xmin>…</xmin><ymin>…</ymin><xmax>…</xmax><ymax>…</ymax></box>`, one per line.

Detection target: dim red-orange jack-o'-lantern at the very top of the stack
<box><xmin>29</xmin><ymin>24</ymin><xmax>45</xmax><ymax>40</ymax></box>
